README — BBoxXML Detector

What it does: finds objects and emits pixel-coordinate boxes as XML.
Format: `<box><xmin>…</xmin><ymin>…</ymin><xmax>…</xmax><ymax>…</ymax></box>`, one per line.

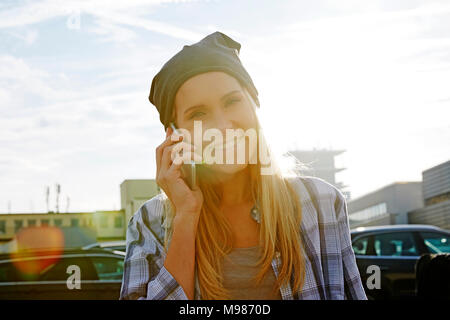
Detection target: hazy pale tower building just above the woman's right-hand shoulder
<box><xmin>289</xmin><ymin>149</ymin><xmax>350</xmax><ymax>200</ymax></box>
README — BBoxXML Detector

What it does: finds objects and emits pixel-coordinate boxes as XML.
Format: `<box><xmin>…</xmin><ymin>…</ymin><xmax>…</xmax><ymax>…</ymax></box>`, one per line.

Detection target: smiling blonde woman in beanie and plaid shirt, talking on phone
<box><xmin>120</xmin><ymin>32</ymin><xmax>366</xmax><ymax>299</ymax></box>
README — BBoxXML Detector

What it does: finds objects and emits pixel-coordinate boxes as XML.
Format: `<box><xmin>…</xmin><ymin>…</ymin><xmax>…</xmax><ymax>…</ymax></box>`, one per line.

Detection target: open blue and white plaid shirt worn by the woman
<box><xmin>120</xmin><ymin>176</ymin><xmax>367</xmax><ymax>300</ymax></box>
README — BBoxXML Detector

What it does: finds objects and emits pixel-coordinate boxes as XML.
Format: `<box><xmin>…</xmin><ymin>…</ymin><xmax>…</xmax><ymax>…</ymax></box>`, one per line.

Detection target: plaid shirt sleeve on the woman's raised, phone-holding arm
<box><xmin>119</xmin><ymin>199</ymin><xmax>188</xmax><ymax>300</ymax></box>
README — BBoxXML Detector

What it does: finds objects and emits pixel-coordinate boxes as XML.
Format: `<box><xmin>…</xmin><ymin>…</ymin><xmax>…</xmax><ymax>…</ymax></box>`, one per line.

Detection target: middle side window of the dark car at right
<box><xmin>374</xmin><ymin>232</ymin><xmax>419</xmax><ymax>256</ymax></box>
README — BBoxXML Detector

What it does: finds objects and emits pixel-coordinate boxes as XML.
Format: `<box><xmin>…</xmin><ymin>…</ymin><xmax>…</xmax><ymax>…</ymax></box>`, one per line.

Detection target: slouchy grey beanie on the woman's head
<box><xmin>149</xmin><ymin>31</ymin><xmax>259</xmax><ymax>129</ymax></box>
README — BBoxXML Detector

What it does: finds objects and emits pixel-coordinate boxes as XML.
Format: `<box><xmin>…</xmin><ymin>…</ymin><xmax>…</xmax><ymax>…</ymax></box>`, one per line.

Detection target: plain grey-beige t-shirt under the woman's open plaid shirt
<box><xmin>222</xmin><ymin>246</ymin><xmax>281</xmax><ymax>300</ymax></box>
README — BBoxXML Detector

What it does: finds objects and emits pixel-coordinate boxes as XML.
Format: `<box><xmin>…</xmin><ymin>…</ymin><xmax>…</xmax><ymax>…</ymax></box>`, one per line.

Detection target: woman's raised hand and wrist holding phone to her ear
<box><xmin>156</xmin><ymin>127</ymin><xmax>203</xmax><ymax>223</ymax></box>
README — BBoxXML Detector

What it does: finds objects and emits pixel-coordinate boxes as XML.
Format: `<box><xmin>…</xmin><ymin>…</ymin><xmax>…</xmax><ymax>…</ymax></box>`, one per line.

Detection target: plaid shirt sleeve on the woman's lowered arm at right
<box><xmin>335</xmin><ymin>189</ymin><xmax>367</xmax><ymax>300</ymax></box>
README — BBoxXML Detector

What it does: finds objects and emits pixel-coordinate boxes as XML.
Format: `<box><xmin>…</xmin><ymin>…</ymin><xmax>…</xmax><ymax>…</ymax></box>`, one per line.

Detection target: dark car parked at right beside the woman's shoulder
<box><xmin>351</xmin><ymin>225</ymin><xmax>450</xmax><ymax>300</ymax></box>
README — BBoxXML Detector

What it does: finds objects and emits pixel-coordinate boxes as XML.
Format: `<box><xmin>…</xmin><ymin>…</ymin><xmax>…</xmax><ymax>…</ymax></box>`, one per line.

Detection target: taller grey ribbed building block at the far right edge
<box><xmin>409</xmin><ymin>160</ymin><xmax>450</xmax><ymax>230</ymax></box>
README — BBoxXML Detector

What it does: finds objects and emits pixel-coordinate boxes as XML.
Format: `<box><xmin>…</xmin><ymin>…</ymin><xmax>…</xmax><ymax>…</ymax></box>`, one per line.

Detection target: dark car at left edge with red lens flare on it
<box><xmin>0</xmin><ymin>249</ymin><xmax>125</xmax><ymax>300</ymax></box>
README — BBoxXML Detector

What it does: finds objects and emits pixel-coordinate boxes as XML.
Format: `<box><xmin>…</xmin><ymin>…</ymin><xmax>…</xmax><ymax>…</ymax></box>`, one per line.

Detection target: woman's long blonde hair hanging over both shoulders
<box><xmin>164</xmin><ymin>88</ymin><xmax>305</xmax><ymax>300</ymax></box>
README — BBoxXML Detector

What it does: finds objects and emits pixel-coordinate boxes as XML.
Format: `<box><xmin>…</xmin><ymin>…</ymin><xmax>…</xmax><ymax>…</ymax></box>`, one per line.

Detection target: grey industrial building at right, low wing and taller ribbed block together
<box><xmin>347</xmin><ymin>160</ymin><xmax>450</xmax><ymax>230</ymax></box>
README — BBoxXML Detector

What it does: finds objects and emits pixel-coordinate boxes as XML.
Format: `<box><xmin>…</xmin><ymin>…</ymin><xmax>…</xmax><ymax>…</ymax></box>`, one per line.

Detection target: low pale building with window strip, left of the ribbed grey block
<box><xmin>347</xmin><ymin>181</ymin><xmax>423</xmax><ymax>228</ymax></box>
